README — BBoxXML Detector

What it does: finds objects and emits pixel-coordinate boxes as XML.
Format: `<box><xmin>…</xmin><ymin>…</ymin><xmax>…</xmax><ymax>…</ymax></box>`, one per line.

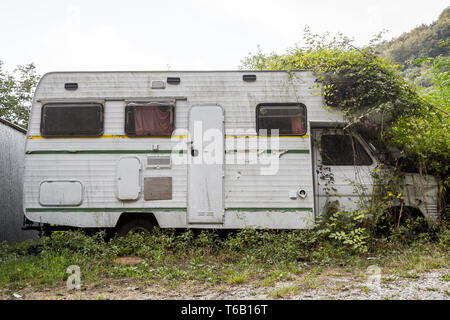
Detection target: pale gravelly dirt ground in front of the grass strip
<box><xmin>0</xmin><ymin>269</ymin><xmax>450</xmax><ymax>300</ymax></box>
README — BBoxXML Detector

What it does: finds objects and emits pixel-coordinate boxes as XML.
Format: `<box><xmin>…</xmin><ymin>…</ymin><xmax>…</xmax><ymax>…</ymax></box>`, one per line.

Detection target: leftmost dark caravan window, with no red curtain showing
<box><xmin>41</xmin><ymin>103</ymin><xmax>103</xmax><ymax>137</ymax></box>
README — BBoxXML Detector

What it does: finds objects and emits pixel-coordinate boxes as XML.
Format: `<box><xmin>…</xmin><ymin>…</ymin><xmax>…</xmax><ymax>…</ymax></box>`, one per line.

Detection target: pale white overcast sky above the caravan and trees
<box><xmin>0</xmin><ymin>0</ymin><xmax>449</xmax><ymax>74</ymax></box>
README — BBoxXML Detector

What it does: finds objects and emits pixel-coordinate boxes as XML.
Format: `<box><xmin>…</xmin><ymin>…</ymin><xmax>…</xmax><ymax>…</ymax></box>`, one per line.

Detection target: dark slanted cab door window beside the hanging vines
<box><xmin>321</xmin><ymin>135</ymin><xmax>372</xmax><ymax>166</ymax></box>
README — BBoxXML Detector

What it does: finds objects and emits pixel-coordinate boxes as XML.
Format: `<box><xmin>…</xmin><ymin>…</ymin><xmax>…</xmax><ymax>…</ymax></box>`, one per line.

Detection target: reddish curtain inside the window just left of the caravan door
<box><xmin>133</xmin><ymin>105</ymin><xmax>173</xmax><ymax>136</ymax></box>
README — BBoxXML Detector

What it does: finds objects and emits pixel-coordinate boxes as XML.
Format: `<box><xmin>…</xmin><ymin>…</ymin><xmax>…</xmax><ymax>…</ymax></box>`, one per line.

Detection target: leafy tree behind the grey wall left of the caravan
<box><xmin>0</xmin><ymin>60</ymin><xmax>39</xmax><ymax>128</ymax></box>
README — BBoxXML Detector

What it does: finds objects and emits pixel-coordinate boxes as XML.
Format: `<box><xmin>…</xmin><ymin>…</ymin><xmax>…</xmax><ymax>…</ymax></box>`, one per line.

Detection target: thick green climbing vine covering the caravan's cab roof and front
<box><xmin>241</xmin><ymin>27</ymin><xmax>450</xmax><ymax>222</ymax></box>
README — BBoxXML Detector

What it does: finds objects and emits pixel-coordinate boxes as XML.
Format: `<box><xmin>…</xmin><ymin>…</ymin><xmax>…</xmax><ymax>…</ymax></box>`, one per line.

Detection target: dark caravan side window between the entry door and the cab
<box><xmin>256</xmin><ymin>103</ymin><xmax>306</xmax><ymax>136</ymax></box>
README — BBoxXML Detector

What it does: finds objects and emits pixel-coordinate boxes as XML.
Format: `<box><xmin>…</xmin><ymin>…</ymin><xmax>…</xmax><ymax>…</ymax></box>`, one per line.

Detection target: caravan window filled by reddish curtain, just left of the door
<box><xmin>125</xmin><ymin>102</ymin><xmax>175</xmax><ymax>137</ymax></box>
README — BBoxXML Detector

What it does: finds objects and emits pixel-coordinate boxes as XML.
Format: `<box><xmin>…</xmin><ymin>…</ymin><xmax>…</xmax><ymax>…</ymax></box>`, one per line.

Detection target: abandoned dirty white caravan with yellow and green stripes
<box><xmin>24</xmin><ymin>71</ymin><xmax>438</xmax><ymax>234</ymax></box>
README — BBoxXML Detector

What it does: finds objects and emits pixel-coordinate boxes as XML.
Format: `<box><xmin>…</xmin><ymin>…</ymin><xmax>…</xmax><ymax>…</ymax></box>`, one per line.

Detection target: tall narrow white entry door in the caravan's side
<box><xmin>187</xmin><ymin>105</ymin><xmax>224</xmax><ymax>224</ymax></box>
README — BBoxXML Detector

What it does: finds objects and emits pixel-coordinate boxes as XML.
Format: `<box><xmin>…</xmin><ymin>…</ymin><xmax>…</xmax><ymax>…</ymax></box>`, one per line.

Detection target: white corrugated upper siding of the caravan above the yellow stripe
<box><xmin>29</xmin><ymin>72</ymin><xmax>342</xmax><ymax>135</ymax></box>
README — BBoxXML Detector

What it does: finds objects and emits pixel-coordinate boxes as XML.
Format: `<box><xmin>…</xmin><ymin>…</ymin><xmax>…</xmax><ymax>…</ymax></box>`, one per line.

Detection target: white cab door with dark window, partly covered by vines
<box><xmin>311</xmin><ymin>129</ymin><xmax>377</xmax><ymax>214</ymax></box>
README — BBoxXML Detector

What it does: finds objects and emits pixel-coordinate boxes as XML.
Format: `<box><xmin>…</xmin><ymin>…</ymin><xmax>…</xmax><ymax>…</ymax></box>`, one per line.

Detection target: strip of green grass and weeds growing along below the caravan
<box><xmin>0</xmin><ymin>229</ymin><xmax>450</xmax><ymax>297</ymax></box>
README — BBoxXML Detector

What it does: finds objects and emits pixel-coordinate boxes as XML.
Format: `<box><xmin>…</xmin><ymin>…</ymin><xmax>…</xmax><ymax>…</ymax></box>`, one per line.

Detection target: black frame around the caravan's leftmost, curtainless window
<box><xmin>40</xmin><ymin>101</ymin><xmax>105</xmax><ymax>138</ymax></box>
